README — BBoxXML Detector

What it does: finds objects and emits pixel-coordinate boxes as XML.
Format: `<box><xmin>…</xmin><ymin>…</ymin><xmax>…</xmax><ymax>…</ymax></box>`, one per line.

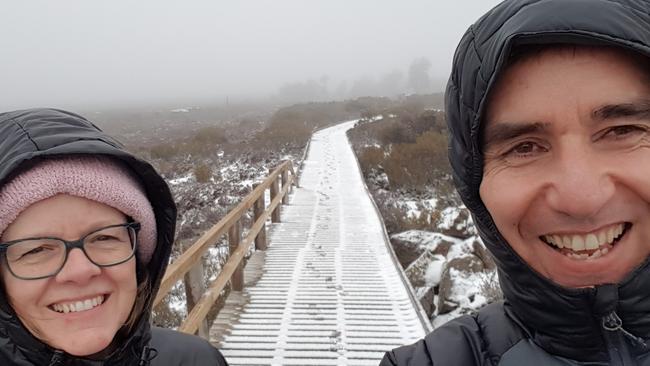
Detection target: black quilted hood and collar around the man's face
<box><xmin>445</xmin><ymin>0</ymin><xmax>650</xmax><ymax>361</ymax></box>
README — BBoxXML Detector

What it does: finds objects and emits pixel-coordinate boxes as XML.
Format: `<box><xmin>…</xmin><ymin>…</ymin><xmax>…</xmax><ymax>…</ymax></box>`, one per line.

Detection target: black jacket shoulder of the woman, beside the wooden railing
<box><xmin>151</xmin><ymin>327</ymin><xmax>228</xmax><ymax>366</ymax></box>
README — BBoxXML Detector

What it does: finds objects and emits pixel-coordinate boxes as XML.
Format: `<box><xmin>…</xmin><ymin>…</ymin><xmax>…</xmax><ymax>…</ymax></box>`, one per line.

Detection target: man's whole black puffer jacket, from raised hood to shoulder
<box><xmin>381</xmin><ymin>0</ymin><xmax>650</xmax><ymax>366</ymax></box>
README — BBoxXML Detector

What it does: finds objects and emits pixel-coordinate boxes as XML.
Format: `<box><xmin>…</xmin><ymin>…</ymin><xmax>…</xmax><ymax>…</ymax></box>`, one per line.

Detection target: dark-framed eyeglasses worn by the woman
<box><xmin>0</xmin><ymin>222</ymin><xmax>140</xmax><ymax>280</ymax></box>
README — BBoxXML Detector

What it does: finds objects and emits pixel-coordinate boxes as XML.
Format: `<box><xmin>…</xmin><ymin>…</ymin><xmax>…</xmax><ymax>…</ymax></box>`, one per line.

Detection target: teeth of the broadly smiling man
<box><xmin>544</xmin><ymin>224</ymin><xmax>625</xmax><ymax>259</ymax></box>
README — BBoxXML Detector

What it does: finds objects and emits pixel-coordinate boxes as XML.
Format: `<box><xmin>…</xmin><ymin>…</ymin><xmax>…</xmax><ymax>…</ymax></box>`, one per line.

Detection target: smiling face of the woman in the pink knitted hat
<box><xmin>2</xmin><ymin>194</ymin><xmax>137</xmax><ymax>356</ymax></box>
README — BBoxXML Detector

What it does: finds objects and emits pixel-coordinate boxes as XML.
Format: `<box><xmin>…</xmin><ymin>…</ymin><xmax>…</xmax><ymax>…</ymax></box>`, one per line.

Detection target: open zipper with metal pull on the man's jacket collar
<box><xmin>602</xmin><ymin>311</ymin><xmax>648</xmax><ymax>366</ymax></box>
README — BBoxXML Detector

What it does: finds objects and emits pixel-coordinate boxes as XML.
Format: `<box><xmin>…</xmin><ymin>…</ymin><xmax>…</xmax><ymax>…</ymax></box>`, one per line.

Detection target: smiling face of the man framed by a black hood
<box><xmin>480</xmin><ymin>48</ymin><xmax>650</xmax><ymax>287</ymax></box>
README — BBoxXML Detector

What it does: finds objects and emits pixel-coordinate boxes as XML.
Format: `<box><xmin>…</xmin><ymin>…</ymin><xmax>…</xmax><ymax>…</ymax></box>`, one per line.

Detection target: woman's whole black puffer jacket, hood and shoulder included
<box><xmin>0</xmin><ymin>109</ymin><xmax>227</xmax><ymax>366</ymax></box>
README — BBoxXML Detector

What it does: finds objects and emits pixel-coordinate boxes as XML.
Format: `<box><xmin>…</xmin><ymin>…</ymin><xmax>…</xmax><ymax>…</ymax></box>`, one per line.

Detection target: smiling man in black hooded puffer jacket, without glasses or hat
<box><xmin>382</xmin><ymin>0</ymin><xmax>650</xmax><ymax>366</ymax></box>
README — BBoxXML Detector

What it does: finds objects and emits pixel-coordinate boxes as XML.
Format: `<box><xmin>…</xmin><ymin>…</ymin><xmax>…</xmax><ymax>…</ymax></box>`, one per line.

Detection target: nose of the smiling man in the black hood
<box><xmin>545</xmin><ymin>148</ymin><xmax>616</xmax><ymax>218</ymax></box>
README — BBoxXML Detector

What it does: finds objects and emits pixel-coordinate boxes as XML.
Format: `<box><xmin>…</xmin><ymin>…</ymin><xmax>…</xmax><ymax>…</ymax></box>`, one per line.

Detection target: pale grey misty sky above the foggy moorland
<box><xmin>0</xmin><ymin>0</ymin><xmax>498</xmax><ymax>111</ymax></box>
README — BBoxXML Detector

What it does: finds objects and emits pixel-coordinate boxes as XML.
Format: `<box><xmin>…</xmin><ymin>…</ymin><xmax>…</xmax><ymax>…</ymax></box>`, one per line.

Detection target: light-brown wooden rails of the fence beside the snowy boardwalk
<box><xmin>154</xmin><ymin>161</ymin><xmax>297</xmax><ymax>333</ymax></box>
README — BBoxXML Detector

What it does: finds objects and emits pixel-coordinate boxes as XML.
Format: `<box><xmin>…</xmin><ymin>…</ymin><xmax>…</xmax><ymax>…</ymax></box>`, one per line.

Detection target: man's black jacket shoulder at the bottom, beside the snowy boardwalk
<box><xmin>379</xmin><ymin>315</ymin><xmax>492</xmax><ymax>366</ymax></box>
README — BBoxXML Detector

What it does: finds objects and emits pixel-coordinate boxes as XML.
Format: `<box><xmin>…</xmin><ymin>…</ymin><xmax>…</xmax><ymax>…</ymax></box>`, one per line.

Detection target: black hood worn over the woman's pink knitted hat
<box><xmin>0</xmin><ymin>109</ymin><xmax>176</xmax><ymax>365</ymax></box>
